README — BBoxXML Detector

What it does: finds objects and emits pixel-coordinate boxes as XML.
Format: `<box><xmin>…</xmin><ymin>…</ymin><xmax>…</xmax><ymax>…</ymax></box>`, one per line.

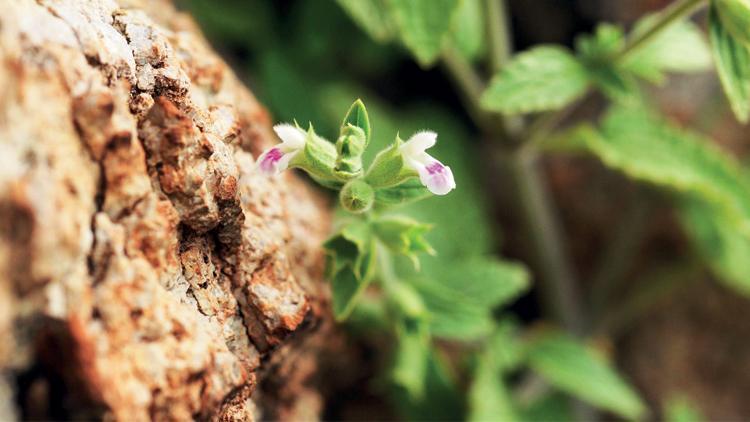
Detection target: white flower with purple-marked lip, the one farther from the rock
<box><xmin>399</xmin><ymin>131</ymin><xmax>456</xmax><ymax>195</ymax></box>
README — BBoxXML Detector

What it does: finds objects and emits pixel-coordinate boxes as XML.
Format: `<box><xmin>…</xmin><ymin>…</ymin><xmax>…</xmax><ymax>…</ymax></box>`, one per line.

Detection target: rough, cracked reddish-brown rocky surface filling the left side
<box><xmin>0</xmin><ymin>0</ymin><xmax>335</xmax><ymax>420</ymax></box>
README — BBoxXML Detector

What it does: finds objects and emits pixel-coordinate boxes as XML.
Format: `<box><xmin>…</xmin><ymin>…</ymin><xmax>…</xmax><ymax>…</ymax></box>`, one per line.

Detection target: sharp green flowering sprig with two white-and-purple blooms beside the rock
<box><xmin>257</xmin><ymin>100</ymin><xmax>456</xmax><ymax>320</ymax></box>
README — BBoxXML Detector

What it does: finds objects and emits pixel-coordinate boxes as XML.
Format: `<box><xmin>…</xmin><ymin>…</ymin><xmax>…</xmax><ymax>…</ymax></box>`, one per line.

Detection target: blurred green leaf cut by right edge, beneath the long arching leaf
<box><xmin>680</xmin><ymin>198</ymin><xmax>750</xmax><ymax>296</ymax></box>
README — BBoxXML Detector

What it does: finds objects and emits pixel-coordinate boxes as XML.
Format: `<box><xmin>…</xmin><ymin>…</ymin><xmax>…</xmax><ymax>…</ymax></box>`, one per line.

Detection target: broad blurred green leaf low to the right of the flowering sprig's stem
<box><xmin>413</xmin><ymin>258</ymin><xmax>529</xmax><ymax>340</ymax></box>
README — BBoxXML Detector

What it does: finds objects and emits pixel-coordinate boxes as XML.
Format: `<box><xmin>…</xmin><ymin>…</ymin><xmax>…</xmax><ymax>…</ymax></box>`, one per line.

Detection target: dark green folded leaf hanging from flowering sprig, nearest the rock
<box><xmin>323</xmin><ymin>221</ymin><xmax>375</xmax><ymax>320</ymax></box>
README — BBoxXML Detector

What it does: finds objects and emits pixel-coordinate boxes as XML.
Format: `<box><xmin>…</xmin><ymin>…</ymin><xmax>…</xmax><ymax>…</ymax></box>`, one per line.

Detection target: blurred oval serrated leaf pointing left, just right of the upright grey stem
<box><xmin>481</xmin><ymin>46</ymin><xmax>589</xmax><ymax>114</ymax></box>
